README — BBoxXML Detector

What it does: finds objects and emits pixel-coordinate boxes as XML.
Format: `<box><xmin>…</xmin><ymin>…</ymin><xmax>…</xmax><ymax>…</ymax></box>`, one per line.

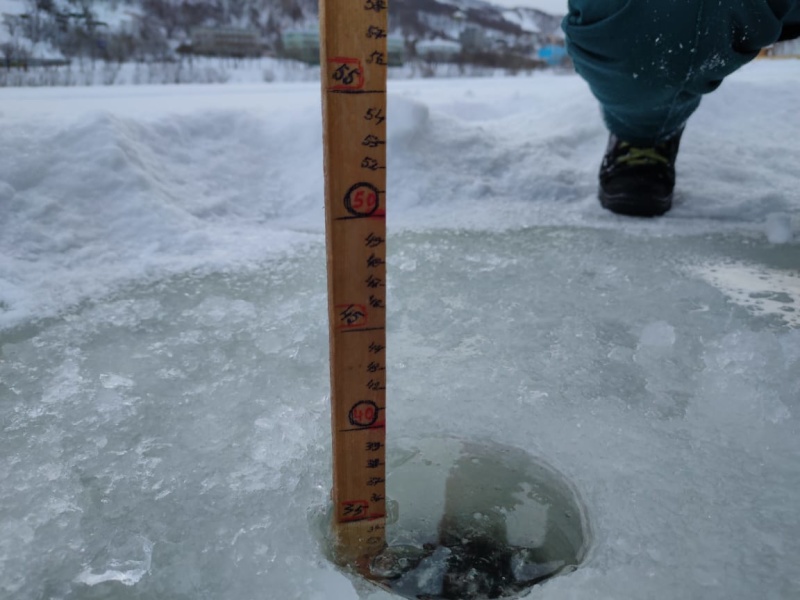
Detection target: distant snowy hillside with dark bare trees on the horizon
<box><xmin>0</xmin><ymin>0</ymin><xmax>559</xmax><ymax>66</ymax></box>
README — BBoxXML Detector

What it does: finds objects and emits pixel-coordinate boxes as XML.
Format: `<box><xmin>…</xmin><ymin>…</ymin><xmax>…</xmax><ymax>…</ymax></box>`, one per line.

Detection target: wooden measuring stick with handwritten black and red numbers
<box><xmin>320</xmin><ymin>0</ymin><xmax>388</xmax><ymax>564</ymax></box>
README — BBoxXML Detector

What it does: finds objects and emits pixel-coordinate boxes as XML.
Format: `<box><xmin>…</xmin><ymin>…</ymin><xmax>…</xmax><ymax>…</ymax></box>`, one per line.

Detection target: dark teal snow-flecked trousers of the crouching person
<box><xmin>562</xmin><ymin>0</ymin><xmax>800</xmax><ymax>145</ymax></box>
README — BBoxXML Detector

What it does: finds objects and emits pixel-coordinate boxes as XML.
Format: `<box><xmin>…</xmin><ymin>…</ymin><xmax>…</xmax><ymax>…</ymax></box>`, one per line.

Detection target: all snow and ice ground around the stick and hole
<box><xmin>0</xmin><ymin>61</ymin><xmax>800</xmax><ymax>600</ymax></box>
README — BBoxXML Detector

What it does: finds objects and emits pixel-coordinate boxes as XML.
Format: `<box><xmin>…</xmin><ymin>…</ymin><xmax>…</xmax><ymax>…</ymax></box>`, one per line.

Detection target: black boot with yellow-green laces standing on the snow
<box><xmin>598</xmin><ymin>131</ymin><xmax>683</xmax><ymax>217</ymax></box>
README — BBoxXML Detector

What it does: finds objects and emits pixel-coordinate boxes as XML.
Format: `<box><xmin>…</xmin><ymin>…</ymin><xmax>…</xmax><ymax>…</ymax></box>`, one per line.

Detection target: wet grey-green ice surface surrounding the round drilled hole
<box><xmin>0</xmin><ymin>228</ymin><xmax>800</xmax><ymax>599</ymax></box>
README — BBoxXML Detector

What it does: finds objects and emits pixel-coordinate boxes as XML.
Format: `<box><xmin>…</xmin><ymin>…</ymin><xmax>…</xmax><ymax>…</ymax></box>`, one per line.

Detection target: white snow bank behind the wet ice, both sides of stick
<box><xmin>0</xmin><ymin>62</ymin><xmax>800</xmax><ymax>326</ymax></box>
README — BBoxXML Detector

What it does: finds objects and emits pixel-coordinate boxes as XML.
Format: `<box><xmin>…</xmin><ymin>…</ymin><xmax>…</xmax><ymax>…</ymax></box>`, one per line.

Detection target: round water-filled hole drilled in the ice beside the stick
<box><xmin>318</xmin><ymin>437</ymin><xmax>590</xmax><ymax>600</ymax></box>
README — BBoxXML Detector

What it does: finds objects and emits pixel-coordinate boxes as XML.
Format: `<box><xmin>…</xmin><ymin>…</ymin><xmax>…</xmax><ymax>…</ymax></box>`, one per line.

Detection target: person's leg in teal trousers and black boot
<box><xmin>562</xmin><ymin>0</ymin><xmax>800</xmax><ymax>216</ymax></box>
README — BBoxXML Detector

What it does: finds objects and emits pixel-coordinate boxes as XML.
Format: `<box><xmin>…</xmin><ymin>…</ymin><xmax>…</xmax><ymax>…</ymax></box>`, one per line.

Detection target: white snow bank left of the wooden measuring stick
<box><xmin>0</xmin><ymin>83</ymin><xmax>322</xmax><ymax>323</ymax></box>
